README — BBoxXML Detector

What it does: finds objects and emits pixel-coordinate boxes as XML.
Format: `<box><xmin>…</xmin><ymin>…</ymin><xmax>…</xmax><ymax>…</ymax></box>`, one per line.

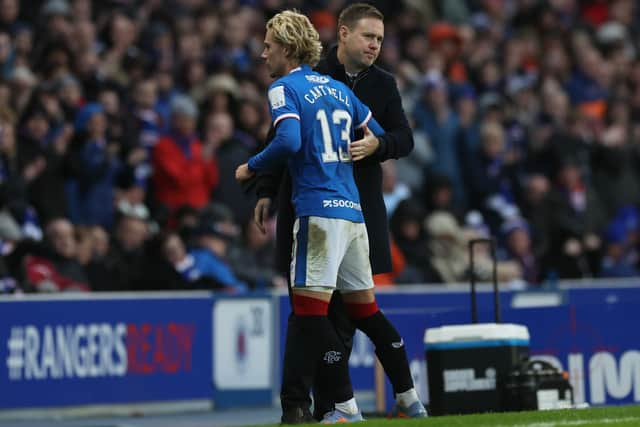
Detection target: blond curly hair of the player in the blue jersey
<box><xmin>267</xmin><ymin>10</ymin><xmax>322</xmax><ymax>67</ymax></box>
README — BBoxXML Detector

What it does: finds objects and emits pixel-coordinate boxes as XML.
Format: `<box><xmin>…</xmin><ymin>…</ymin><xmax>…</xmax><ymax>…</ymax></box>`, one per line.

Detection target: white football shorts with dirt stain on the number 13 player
<box><xmin>291</xmin><ymin>216</ymin><xmax>373</xmax><ymax>292</ymax></box>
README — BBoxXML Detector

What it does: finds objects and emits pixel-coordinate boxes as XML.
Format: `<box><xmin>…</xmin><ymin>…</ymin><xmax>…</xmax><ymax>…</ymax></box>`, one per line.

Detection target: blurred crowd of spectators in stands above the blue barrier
<box><xmin>0</xmin><ymin>0</ymin><xmax>640</xmax><ymax>294</ymax></box>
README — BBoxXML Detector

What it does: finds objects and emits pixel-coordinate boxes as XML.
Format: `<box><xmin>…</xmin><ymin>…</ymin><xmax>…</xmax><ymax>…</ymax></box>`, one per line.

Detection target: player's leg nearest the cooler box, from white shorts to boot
<box><xmin>338</xmin><ymin>227</ymin><xmax>426</xmax><ymax>417</ymax></box>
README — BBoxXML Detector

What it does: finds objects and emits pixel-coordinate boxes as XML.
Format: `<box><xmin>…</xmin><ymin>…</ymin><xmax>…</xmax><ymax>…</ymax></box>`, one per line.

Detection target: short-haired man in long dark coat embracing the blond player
<box><xmin>254</xmin><ymin>4</ymin><xmax>426</xmax><ymax>424</ymax></box>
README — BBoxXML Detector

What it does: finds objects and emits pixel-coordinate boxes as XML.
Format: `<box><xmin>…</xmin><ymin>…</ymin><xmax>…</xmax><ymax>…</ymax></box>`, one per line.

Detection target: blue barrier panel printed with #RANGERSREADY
<box><xmin>0</xmin><ymin>294</ymin><xmax>212</xmax><ymax>409</ymax></box>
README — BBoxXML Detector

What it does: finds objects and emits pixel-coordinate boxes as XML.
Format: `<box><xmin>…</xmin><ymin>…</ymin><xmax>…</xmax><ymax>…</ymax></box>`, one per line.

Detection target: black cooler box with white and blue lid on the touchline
<box><xmin>424</xmin><ymin>323</ymin><xmax>529</xmax><ymax>415</ymax></box>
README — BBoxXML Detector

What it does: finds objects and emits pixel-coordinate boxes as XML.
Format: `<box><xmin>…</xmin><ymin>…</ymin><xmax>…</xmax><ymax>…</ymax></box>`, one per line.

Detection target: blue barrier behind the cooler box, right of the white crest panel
<box><xmin>280</xmin><ymin>283</ymin><xmax>640</xmax><ymax>410</ymax></box>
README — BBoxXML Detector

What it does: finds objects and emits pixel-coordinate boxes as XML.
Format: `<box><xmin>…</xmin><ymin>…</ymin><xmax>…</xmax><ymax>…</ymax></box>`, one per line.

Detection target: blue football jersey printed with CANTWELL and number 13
<box><xmin>255</xmin><ymin>65</ymin><xmax>379</xmax><ymax>222</ymax></box>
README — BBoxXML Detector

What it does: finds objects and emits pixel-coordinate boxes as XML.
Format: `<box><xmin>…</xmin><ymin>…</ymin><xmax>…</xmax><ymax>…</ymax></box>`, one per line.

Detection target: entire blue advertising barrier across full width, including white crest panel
<box><xmin>0</xmin><ymin>283</ymin><xmax>640</xmax><ymax>411</ymax></box>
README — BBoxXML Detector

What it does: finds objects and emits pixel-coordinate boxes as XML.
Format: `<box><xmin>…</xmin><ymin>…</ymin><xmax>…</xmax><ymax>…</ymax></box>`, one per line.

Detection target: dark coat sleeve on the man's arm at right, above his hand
<box><xmin>374</xmin><ymin>73</ymin><xmax>413</xmax><ymax>162</ymax></box>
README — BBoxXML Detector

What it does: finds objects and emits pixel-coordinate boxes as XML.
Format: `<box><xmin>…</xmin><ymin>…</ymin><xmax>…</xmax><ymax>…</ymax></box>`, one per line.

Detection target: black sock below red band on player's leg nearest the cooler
<box><xmin>354</xmin><ymin>310</ymin><xmax>413</xmax><ymax>393</ymax></box>
